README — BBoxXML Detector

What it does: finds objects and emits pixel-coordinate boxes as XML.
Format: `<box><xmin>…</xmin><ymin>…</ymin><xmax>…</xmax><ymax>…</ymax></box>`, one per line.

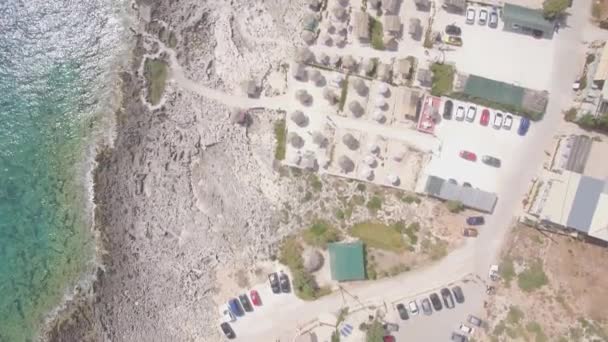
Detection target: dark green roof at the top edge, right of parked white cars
<box><xmin>502</xmin><ymin>3</ymin><xmax>555</xmax><ymax>39</ymax></box>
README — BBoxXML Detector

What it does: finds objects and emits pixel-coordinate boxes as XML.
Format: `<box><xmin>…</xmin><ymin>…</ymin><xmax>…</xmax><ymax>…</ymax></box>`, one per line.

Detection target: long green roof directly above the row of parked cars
<box><xmin>464</xmin><ymin>75</ymin><xmax>525</xmax><ymax>108</ymax></box>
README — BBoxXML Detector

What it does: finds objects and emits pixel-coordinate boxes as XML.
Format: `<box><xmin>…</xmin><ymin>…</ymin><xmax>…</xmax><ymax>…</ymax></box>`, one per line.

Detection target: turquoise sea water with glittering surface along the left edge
<box><xmin>0</xmin><ymin>0</ymin><xmax>128</xmax><ymax>342</ymax></box>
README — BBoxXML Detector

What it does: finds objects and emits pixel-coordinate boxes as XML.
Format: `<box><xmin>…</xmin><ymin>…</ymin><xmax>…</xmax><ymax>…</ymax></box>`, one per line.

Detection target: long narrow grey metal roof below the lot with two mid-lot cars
<box><xmin>425</xmin><ymin>176</ymin><xmax>498</xmax><ymax>213</ymax></box>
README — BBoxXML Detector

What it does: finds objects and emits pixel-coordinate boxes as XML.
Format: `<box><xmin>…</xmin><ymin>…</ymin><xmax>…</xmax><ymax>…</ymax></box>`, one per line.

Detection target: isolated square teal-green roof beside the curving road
<box><xmin>328</xmin><ymin>241</ymin><xmax>365</xmax><ymax>281</ymax></box>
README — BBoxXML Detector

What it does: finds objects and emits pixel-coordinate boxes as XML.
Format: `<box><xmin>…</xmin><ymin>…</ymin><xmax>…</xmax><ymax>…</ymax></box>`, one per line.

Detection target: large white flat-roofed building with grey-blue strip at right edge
<box><xmin>528</xmin><ymin>170</ymin><xmax>608</xmax><ymax>241</ymax></box>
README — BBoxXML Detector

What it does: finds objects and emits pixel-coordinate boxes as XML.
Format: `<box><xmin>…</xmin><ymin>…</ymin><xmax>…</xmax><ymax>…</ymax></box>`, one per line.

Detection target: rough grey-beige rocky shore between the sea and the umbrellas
<box><xmin>42</xmin><ymin>1</ymin><xmax>304</xmax><ymax>341</ymax></box>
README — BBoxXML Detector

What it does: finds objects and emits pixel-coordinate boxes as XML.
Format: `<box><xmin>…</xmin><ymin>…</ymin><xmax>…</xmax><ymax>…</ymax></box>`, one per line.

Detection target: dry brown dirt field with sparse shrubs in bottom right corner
<box><xmin>480</xmin><ymin>225</ymin><xmax>608</xmax><ymax>342</ymax></box>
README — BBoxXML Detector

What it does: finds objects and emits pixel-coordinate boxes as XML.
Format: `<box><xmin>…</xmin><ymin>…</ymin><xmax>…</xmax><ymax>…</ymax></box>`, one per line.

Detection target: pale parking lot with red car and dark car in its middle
<box><xmin>424</xmin><ymin>98</ymin><xmax>534</xmax><ymax>193</ymax></box>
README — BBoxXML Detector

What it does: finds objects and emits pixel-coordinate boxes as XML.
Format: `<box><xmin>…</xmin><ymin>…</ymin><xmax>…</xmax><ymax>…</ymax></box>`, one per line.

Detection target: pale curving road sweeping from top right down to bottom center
<box><xmin>227</xmin><ymin>0</ymin><xmax>597</xmax><ymax>341</ymax></box>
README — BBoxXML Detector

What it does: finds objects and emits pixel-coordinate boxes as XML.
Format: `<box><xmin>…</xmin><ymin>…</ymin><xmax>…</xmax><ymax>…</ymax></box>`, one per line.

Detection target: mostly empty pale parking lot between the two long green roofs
<box><xmin>433</xmin><ymin>6</ymin><xmax>555</xmax><ymax>90</ymax></box>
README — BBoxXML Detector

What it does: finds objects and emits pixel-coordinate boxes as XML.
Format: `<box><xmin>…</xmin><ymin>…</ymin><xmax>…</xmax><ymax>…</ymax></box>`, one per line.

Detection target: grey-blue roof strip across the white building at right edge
<box><xmin>566</xmin><ymin>176</ymin><xmax>604</xmax><ymax>233</ymax></box>
